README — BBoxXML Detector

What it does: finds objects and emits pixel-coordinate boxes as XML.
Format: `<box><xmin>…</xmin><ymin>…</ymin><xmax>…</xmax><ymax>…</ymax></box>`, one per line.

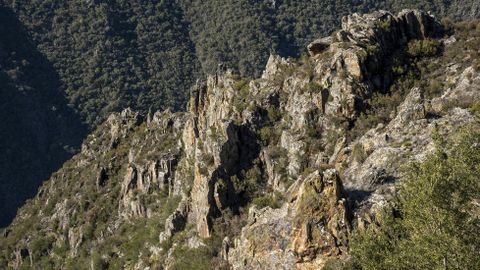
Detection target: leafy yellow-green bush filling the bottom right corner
<box><xmin>351</xmin><ymin>127</ymin><xmax>480</xmax><ymax>269</ymax></box>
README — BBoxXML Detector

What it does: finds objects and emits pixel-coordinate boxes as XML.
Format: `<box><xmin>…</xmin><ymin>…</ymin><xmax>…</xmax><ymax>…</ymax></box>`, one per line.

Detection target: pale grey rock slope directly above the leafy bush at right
<box><xmin>336</xmin><ymin>88</ymin><xmax>476</xmax><ymax>226</ymax></box>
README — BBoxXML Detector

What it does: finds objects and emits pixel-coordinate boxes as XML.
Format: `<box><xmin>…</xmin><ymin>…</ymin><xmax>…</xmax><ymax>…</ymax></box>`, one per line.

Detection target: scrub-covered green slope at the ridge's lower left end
<box><xmin>0</xmin><ymin>115</ymin><xmax>185</xmax><ymax>269</ymax></box>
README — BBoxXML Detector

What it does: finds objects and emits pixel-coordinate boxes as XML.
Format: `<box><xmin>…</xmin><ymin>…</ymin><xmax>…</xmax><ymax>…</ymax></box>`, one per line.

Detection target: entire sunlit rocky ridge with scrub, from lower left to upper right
<box><xmin>0</xmin><ymin>10</ymin><xmax>480</xmax><ymax>269</ymax></box>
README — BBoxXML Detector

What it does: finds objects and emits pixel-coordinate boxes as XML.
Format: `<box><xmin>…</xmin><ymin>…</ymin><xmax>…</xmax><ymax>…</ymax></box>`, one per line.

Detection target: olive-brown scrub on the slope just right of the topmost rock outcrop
<box><xmin>343</xmin><ymin>20</ymin><xmax>480</xmax><ymax>140</ymax></box>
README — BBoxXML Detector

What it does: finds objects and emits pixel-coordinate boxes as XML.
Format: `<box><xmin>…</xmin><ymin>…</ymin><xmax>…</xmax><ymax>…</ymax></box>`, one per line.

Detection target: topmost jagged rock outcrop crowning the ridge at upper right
<box><xmin>309</xmin><ymin>10</ymin><xmax>442</xmax><ymax>117</ymax></box>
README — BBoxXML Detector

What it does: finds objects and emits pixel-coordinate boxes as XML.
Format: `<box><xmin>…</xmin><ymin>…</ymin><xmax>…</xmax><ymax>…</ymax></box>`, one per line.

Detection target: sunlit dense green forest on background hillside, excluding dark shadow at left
<box><xmin>6</xmin><ymin>0</ymin><xmax>479</xmax><ymax>125</ymax></box>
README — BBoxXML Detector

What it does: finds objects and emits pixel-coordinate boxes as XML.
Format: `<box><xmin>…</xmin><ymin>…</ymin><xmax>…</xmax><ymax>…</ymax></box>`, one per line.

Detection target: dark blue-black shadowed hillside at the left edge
<box><xmin>0</xmin><ymin>5</ymin><xmax>87</xmax><ymax>227</ymax></box>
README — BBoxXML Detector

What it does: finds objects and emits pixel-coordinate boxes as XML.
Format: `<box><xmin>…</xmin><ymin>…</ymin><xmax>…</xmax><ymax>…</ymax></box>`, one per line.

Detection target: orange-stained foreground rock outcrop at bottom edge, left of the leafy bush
<box><xmin>228</xmin><ymin>169</ymin><xmax>350</xmax><ymax>269</ymax></box>
